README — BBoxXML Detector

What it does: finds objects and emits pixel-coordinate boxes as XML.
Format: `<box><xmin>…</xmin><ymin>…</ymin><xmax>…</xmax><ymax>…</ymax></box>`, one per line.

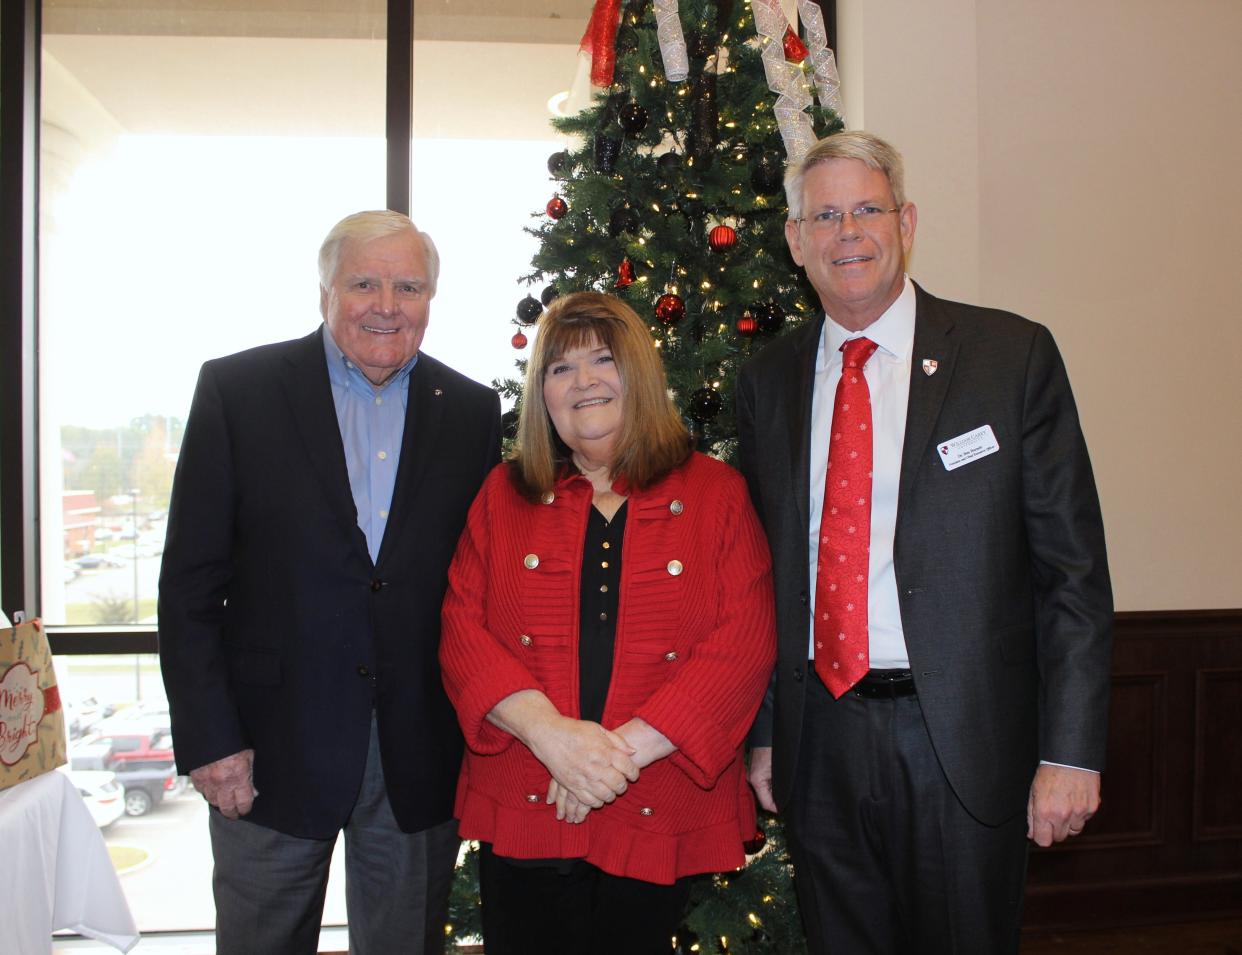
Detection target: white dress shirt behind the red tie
<box><xmin>806</xmin><ymin>277</ymin><xmax>914</xmax><ymax>669</ymax></box>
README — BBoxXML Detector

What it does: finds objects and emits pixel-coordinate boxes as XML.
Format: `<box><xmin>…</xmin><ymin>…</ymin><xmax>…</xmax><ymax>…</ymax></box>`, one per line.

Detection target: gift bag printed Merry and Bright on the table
<box><xmin>0</xmin><ymin>620</ymin><xmax>65</xmax><ymax>790</ymax></box>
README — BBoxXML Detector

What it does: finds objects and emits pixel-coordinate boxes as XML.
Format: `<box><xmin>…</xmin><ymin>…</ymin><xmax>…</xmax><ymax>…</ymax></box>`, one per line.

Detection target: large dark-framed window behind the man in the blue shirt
<box><xmin>0</xmin><ymin>0</ymin><xmax>592</xmax><ymax>931</ymax></box>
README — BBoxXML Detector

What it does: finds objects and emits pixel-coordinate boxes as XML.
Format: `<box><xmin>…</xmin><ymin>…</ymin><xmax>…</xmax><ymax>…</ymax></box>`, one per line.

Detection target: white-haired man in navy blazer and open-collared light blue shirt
<box><xmin>159</xmin><ymin>212</ymin><xmax>501</xmax><ymax>955</ymax></box>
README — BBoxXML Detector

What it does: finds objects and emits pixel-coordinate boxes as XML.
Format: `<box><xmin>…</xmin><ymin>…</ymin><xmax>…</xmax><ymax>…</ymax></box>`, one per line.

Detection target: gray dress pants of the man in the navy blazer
<box><xmin>210</xmin><ymin>718</ymin><xmax>461</xmax><ymax>955</ymax></box>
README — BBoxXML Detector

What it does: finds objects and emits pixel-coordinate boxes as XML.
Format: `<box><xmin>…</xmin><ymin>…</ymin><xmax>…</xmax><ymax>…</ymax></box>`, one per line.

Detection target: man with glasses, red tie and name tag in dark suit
<box><xmin>738</xmin><ymin>132</ymin><xmax>1113</xmax><ymax>955</ymax></box>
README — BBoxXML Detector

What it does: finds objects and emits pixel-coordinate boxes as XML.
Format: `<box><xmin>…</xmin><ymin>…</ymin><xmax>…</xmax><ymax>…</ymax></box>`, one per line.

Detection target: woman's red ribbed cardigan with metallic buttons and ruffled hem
<box><xmin>440</xmin><ymin>453</ymin><xmax>776</xmax><ymax>884</ymax></box>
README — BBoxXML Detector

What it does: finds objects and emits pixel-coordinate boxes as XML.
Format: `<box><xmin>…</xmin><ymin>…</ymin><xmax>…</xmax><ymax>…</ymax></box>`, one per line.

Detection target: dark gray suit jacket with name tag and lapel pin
<box><xmin>737</xmin><ymin>280</ymin><xmax>1113</xmax><ymax>825</ymax></box>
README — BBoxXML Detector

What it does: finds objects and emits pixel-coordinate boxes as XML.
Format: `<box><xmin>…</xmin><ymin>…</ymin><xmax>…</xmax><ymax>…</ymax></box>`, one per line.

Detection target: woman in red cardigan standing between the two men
<box><xmin>440</xmin><ymin>292</ymin><xmax>775</xmax><ymax>955</ymax></box>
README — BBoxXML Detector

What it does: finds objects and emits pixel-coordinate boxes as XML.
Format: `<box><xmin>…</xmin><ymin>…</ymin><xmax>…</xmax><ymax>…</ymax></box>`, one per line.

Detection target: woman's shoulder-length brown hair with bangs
<box><xmin>509</xmin><ymin>292</ymin><xmax>693</xmax><ymax>500</ymax></box>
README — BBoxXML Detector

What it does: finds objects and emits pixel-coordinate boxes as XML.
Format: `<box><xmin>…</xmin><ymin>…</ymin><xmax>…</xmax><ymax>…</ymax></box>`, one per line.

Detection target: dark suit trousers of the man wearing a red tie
<box><xmin>785</xmin><ymin>677</ymin><xmax>1033</xmax><ymax>955</ymax></box>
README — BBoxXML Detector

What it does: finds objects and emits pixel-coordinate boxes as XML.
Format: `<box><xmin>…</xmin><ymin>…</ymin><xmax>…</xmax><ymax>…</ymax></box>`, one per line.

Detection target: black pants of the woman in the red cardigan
<box><xmin>478</xmin><ymin>842</ymin><xmax>691</xmax><ymax>955</ymax></box>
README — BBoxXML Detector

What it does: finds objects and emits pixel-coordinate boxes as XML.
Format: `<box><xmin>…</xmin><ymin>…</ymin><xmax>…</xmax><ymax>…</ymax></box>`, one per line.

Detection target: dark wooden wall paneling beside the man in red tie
<box><xmin>1023</xmin><ymin>610</ymin><xmax>1242</xmax><ymax>930</ymax></box>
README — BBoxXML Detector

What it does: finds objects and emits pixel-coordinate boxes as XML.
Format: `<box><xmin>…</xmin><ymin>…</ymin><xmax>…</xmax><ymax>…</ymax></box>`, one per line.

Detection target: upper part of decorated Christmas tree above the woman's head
<box><xmin>494</xmin><ymin>0</ymin><xmax>842</xmax><ymax>461</ymax></box>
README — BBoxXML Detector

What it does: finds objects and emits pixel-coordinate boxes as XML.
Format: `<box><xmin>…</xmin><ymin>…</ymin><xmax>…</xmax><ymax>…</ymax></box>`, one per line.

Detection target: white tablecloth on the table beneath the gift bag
<box><xmin>0</xmin><ymin>772</ymin><xmax>138</xmax><ymax>955</ymax></box>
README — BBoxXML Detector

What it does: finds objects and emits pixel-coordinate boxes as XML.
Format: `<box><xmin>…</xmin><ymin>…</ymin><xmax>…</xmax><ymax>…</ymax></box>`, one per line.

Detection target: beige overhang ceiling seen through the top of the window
<box><xmin>42</xmin><ymin>0</ymin><xmax>592</xmax><ymax>149</ymax></box>
